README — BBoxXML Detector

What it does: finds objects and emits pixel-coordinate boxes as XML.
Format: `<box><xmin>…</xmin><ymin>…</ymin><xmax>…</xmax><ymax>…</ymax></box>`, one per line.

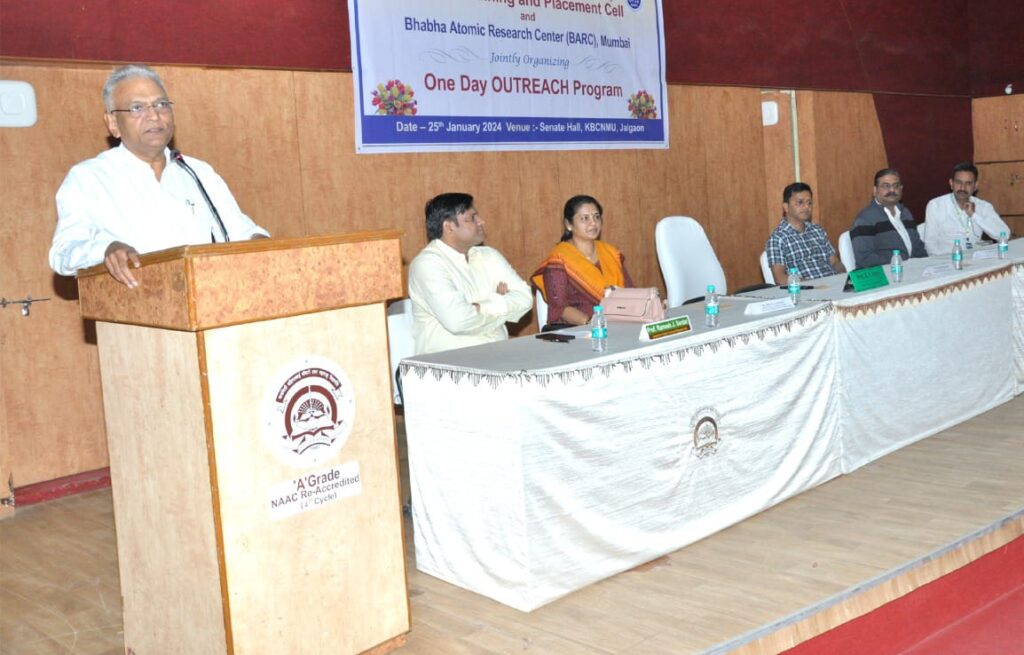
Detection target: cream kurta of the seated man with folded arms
<box><xmin>409</xmin><ymin>238</ymin><xmax>534</xmax><ymax>354</ymax></box>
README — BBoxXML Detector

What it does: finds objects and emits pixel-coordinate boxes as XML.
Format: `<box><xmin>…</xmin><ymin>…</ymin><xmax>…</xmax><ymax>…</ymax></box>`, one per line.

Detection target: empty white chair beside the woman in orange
<box><xmin>654</xmin><ymin>216</ymin><xmax>727</xmax><ymax>307</ymax></box>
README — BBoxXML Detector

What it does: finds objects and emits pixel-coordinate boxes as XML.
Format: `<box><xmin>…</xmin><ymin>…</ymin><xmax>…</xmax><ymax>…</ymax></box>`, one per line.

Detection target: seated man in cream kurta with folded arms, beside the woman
<box><xmin>409</xmin><ymin>193</ymin><xmax>534</xmax><ymax>354</ymax></box>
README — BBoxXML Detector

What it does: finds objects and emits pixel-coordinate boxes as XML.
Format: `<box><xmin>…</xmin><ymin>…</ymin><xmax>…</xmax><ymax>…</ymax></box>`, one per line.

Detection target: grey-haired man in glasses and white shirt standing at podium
<box><xmin>49</xmin><ymin>64</ymin><xmax>269</xmax><ymax>288</ymax></box>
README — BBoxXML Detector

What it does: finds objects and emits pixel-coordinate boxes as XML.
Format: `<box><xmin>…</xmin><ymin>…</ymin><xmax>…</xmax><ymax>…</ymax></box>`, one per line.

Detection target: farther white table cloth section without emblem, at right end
<box><xmin>744</xmin><ymin>250</ymin><xmax>1024</xmax><ymax>473</ymax></box>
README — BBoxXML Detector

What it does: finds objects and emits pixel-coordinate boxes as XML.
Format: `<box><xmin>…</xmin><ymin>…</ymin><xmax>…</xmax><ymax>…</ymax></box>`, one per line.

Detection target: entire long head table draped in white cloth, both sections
<box><xmin>401</xmin><ymin>237</ymin><xmax>1024</xmax><ymax>611</ymax></box>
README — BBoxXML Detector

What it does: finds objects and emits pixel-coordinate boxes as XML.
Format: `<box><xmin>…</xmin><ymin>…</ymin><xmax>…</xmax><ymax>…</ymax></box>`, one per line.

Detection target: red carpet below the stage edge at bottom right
<box><xmin>785</xmin><ymin>537</ymin><xmax>1024</xmax><ymax>655</ymax></box>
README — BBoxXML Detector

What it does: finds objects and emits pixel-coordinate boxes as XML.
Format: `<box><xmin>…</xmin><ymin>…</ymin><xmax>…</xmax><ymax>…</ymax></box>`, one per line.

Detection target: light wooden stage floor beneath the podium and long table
<box><xmin>0</xmin><ymin>396</ymin><xmax>1024</xmax><ymax>655</ymax></box>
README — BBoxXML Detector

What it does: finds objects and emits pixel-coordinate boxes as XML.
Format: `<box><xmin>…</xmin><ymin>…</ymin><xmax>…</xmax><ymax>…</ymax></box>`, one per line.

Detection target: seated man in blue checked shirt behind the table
<box><xmin>765</xmin><ymin>182</ymin><xmax>846</xmax><ymax>285</ymax></box>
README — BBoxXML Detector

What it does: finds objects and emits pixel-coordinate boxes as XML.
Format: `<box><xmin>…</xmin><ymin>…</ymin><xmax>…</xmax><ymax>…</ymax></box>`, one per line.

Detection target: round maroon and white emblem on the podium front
<box><xmin>263</xmin><ymin>357</ymin><xmax>355</xmax><ymax>468</ymax></box>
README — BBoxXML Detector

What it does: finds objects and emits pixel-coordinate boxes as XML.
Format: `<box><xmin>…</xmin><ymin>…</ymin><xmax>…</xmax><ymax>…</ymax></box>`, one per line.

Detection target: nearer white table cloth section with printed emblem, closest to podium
<box><xmin>401</xmin><ymin>299</ymin><xmax>841</xmax><ymax>611</ymax></box>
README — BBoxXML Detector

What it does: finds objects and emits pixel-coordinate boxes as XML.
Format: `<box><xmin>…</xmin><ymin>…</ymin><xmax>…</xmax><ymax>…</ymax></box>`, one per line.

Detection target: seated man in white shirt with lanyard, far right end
<box><xmin>925</xmin><ymin>162</ymin><xmax>1010</xmax><ymax>255</ymax></box>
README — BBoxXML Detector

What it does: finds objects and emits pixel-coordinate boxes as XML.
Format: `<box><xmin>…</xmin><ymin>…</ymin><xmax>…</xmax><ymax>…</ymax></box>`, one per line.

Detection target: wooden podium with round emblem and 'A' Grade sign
<box><xmin>79</xmin><ymin>231</ymin><xmax>410</xmax><ymax>655</ymax></box>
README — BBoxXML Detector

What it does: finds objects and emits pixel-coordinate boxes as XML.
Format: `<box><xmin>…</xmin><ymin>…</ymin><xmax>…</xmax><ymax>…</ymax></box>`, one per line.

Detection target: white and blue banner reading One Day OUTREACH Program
<box><xmin>348</xmin><ymin>0</ymin><xmax>669</xmax><ymax>152</ymax></box>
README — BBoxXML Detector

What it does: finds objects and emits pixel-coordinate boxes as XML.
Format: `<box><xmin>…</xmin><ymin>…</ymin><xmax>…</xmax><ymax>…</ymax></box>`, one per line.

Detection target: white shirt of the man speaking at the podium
<box><xmin>50</xmin><ymin>145</ymin><xmax>267</xmax><ymax>275</ymax></box>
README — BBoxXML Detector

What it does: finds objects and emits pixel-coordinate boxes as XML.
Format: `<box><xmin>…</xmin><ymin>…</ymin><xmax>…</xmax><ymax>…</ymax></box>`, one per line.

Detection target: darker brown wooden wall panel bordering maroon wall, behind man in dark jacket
<box><xmin>798</xmin><ymin>92</ymin><xmax>888</xmax><ymax>246</ymax></box>
